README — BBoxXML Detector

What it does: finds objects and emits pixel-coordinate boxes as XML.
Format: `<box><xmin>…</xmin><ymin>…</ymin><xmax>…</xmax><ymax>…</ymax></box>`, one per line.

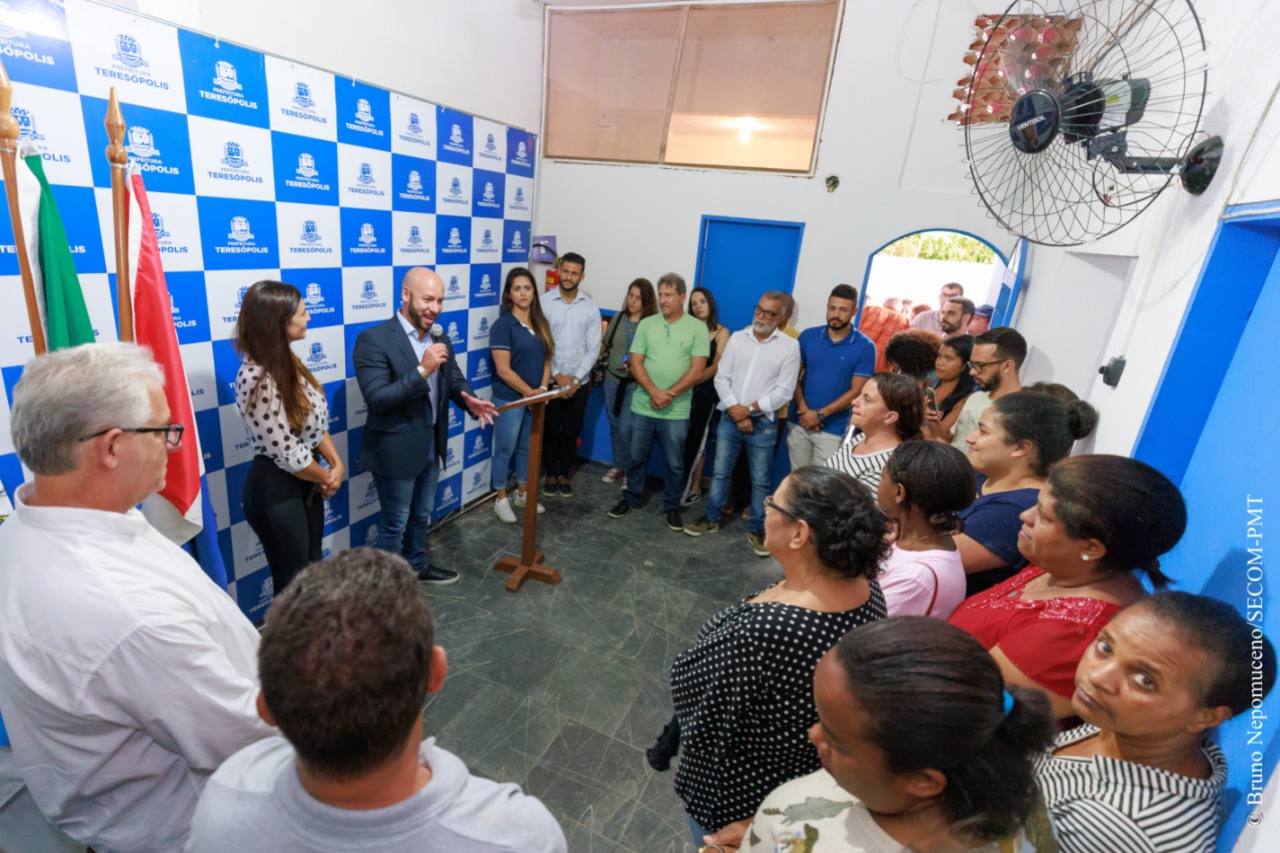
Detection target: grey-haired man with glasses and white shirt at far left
<box><xmin>0</xmin><ymin>343</ymin><xmax>271</xmax><ymax>853</ymax></box>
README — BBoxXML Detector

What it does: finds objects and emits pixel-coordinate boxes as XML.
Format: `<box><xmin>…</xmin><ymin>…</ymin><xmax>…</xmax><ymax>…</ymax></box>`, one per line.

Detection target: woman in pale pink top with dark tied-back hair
<box><xmin>877</xmin><ymin>442</ymin><xmax>974</xmax><ymax>619</ymax></box>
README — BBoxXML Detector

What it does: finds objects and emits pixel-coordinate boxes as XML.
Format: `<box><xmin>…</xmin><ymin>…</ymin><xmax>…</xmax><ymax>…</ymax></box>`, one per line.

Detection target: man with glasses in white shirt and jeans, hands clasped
<box><xmin>685</xmin><ymin>291</ymin><xmax>800</xmax><ymax>557</ymax></box>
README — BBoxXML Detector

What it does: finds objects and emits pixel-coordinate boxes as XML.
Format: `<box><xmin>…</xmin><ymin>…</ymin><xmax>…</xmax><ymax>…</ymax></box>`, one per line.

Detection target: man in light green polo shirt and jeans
<box><xmin>609</xmin><ymin>273</ymin><xmax>710</xmax><ymax>533</ymax></box>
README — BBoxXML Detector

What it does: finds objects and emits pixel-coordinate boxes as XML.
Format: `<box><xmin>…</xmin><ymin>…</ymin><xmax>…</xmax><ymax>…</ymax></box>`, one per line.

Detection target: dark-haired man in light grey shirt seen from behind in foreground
<box><xmin>187</xmin><ymin>548</ymin><xmax>567</xmax><ymax>853</ymax></box>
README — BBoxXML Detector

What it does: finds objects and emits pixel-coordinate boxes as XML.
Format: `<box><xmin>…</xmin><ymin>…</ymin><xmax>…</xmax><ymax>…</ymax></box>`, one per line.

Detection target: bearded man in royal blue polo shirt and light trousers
<box><xmin>787</xmin><ymin>284</ymin><xmax>876</xmax><ymax>470</ymax></box>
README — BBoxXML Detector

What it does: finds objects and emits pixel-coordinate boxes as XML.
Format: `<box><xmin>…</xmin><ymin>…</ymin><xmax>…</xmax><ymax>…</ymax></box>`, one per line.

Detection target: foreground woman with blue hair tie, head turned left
<box><xmin>741</xmin><ymin>616</ymin><xmax>1054</xmax><ymax>853</ymax></box>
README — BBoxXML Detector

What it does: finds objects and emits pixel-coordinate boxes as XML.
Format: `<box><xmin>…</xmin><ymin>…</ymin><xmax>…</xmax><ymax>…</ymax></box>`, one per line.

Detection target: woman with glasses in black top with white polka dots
<box><xmin>671</xmin><ymin>467</ymin><xmax>888</xmax><ymax>845</ymax></box>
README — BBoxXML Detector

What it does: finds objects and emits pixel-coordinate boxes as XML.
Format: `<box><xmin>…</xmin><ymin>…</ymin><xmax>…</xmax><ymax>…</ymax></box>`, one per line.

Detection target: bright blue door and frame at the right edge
<box><xmin>1119</xmin><ymin>202</ymin><xmax>1280</xmax><ymax>850</ymax></box>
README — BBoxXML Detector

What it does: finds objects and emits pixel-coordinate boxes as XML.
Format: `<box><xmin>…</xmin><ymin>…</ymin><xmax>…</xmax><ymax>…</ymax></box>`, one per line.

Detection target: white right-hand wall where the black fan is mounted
<box><xmin>1003</xmin><ymin>0</ymin><xmax>1280</xmax><ymax>453</ymax></box>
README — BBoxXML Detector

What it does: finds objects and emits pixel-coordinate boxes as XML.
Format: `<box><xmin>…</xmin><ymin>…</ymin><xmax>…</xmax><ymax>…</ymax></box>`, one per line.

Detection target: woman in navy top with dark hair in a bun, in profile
<box><xmin>956</xmin><ymin>391</ymin><xmax>1097</xmax><ymax>596</ymax></box>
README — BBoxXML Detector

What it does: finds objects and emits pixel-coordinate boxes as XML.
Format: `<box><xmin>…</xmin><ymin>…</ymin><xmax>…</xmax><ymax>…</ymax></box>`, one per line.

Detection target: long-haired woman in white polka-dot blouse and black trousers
<box><xmin>232</xmin><ymin>280</ymin><xmax>347</xmax><ymax>593</ymax></box>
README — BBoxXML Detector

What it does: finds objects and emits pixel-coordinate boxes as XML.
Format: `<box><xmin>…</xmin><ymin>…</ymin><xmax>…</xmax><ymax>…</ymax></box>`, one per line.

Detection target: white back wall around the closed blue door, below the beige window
<box><xmin>534</xmin><ymin>0</ymin><xmax>1015</xmax><ymax>325</ymax></box>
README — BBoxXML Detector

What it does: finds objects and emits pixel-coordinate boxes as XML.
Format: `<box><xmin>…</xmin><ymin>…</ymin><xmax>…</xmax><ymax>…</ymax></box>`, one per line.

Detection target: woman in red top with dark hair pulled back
<box><xmin>950</xmin><ymin>456</ymin><xmax>1187</xmax><ymax>719</ymax></box>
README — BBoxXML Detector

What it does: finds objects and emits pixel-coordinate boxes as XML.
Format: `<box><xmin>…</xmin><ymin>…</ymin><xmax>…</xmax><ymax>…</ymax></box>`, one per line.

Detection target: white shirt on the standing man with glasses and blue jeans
<box><xmin>713</xmin><ymin>328</ymin><xmax>800</xmax><ymax>420</ymax></box>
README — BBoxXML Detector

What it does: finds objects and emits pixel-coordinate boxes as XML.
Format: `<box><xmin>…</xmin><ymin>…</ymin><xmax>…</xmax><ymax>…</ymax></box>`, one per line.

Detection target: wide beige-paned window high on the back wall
<box><xmin>543</xmin><ymin>0</ymin><xmax>841</xmax><ymax>173</ymax></box>
